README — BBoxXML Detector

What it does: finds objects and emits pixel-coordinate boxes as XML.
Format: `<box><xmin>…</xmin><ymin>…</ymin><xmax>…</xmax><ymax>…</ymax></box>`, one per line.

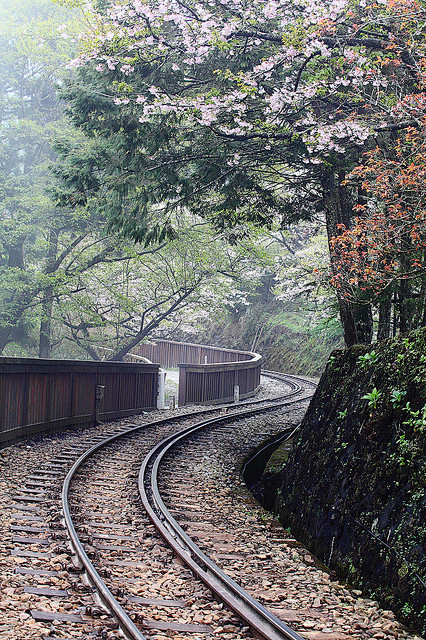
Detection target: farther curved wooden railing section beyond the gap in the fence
<box><xmin>133</xmin><ymin>340</ymin><xmax>262</xmax><ymax>406</ymax></box>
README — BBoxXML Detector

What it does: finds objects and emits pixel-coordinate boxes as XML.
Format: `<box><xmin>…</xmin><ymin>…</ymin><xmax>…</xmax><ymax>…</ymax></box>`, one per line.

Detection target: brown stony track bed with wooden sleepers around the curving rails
<box><xmin>5</xmin><ymin>376</ymin><xmax>418</xmax><ymax>640</ymax></box>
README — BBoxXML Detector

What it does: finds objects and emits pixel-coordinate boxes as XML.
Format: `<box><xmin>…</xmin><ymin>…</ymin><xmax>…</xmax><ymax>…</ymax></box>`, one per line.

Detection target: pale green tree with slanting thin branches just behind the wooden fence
<box><xmin>41</xmin><ymin>214</ymin><xmax>267</xmax><ymax>360</ymax></box>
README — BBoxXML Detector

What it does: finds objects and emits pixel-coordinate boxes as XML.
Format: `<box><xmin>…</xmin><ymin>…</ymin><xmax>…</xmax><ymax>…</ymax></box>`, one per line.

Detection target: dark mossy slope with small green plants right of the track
<box><xmin>265</xmin><ymin>329</ymin><xmax>426</xmax><ymax>633</ymax></box>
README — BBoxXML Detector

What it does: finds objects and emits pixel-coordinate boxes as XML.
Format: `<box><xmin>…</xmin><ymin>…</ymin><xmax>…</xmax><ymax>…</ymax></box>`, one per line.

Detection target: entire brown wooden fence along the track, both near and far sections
<box><xmin>0</xmin><ymin>340</ymin><xmax>262</xmax><ymax>448</ymax></box>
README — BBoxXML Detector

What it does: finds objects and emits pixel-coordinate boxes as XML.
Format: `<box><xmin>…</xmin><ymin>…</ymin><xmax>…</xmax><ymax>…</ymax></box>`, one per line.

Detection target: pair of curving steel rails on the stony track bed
<box><xmin>62</xmin><ymin>374</ymin><xmax>311</xmax><ymax>640</ymax></box>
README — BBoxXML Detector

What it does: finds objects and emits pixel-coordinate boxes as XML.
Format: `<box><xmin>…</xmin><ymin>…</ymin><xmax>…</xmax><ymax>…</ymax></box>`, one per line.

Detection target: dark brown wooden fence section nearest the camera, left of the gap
<box><xmin>0</xmin><ymin>358</ymin><xmax>159</xmax><ymax>446</ymax></box>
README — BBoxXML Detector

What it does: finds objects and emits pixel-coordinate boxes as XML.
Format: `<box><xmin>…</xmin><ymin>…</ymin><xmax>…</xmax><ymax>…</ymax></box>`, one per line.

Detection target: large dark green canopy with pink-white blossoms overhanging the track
<box><xmin>52</xmin><ymin>0</ymin><xmax>425</xmax><ymax>345</ymax></box>
